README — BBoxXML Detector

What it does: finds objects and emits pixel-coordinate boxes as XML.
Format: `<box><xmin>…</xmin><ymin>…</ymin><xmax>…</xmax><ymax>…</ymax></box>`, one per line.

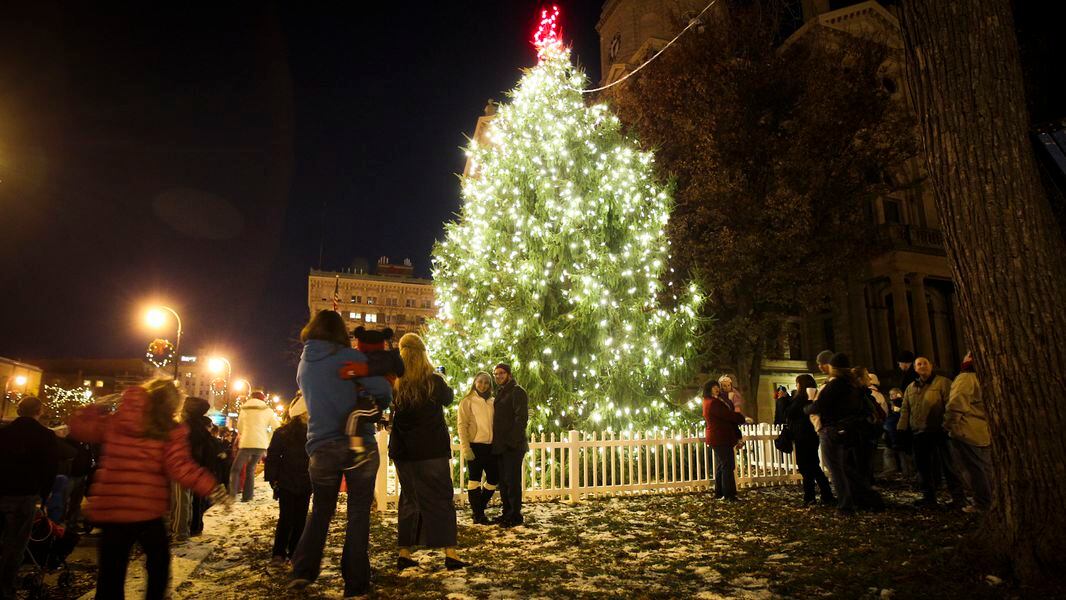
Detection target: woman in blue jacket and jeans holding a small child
<box><xmin>289</xmin><ymin>310</ymin><xmax>390</xmax><ymax>597</ymax></box>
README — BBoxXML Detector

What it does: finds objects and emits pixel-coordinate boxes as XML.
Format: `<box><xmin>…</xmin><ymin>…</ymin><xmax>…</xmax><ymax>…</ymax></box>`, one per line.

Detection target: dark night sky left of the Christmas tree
<box><xmin>0</xmin><ymin>0</ymin><xmax>602</xmax><ymax>393</ymax></box>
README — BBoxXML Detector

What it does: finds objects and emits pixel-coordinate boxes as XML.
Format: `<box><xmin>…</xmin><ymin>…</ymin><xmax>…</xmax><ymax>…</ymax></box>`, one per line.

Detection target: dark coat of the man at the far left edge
<box><xmin>0</xmin><ymin>417</ymin><xmax>60</xmax><ymax>498</ymax></box>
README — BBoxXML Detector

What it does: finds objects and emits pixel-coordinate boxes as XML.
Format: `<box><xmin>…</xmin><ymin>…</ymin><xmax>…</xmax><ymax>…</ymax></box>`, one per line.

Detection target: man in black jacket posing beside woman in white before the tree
<box><xmin>492</xmin><ymin>362</ymin><xmax>530</xmax><ymax>528</ymax></box>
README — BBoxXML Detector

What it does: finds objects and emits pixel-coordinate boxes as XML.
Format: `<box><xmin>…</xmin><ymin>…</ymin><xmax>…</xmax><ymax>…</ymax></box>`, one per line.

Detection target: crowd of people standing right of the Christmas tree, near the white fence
<box><xmin>702</xmin><ymin>351</ymin><xmax>991</xmax><ymax>514</ymax></box>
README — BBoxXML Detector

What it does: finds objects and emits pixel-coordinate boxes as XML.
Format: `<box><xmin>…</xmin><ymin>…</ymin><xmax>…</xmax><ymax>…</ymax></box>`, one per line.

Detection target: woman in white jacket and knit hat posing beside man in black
<box><xmin>456</xmin><ymin>372</ymin><xmax>500</xmax><ymax>525</ymax></box>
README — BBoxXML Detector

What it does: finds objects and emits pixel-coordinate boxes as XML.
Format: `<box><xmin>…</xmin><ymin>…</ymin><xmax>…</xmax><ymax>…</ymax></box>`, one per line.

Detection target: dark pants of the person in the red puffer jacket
<box><xmin>96</xmin><ymin>519</ymin><xmax>171</xmax><ymax>600</ymax></box>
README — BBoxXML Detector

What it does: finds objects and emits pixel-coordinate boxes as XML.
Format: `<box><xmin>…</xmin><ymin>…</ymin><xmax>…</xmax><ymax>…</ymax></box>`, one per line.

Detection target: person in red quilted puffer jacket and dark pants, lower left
<box><xmin>70</xmin><ymin>379</ymin><xmax>229</xmax><ymax>599</ymax></box>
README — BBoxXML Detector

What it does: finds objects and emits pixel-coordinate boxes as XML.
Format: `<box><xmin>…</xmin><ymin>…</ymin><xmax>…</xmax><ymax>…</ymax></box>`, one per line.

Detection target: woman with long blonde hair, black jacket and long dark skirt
<box><xmin>389</xmin><ymin>334</ymin><xmax>467</xmax><ymax>570</ymax></box>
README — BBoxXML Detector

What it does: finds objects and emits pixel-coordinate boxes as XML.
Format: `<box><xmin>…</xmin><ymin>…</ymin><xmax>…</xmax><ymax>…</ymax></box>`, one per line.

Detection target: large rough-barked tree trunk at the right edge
<box><xmin>902</xmin><ymin>0</ymin><xmax>1066</xmax><ymax>586</ymax></box>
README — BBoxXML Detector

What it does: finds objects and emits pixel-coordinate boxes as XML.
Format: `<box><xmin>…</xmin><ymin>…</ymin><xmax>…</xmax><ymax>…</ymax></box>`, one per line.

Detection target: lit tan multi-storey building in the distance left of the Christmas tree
<box><xmin>307</xmin><ymin>257</ymin><xmax>437</xmax><ymax>339</ymax></box>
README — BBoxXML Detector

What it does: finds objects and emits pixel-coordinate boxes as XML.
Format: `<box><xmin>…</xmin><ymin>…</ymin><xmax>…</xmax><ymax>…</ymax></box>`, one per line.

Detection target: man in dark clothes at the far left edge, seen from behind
<box><xmin>0</xmin><ymin>395</ymin><xmax>59</xmax><ymax>600</ymax></box>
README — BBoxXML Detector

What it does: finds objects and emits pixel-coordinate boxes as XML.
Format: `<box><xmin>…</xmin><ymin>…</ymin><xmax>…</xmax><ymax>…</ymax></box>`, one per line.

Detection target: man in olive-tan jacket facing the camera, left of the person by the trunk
<box><xmin>897</xmin><ymin>356</ymin><xmax>966</xmax><ymax>508</ymax></box>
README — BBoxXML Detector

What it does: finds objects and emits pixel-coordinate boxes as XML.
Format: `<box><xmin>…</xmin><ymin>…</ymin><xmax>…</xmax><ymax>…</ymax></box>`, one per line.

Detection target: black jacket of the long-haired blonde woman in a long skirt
<box><xmin>389</xmin><ymin>373</ymin><xmax>455</xmax><ymax>460</ymax></box>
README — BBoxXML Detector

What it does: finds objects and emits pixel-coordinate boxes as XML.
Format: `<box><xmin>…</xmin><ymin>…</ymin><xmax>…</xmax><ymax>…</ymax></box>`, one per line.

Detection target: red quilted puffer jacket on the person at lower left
<box><xmin>70</xmin><ymin>387</ymin><xmax>215</xmax><ymax>523</ymax></box>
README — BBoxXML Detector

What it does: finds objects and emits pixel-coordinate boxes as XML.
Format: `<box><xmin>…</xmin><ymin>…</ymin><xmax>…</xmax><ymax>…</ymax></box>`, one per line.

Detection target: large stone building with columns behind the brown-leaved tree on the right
<box><xmin>596</xmin><ymin>0</ymin><xmax>965</xmax><ymax>421</ymax></box>
